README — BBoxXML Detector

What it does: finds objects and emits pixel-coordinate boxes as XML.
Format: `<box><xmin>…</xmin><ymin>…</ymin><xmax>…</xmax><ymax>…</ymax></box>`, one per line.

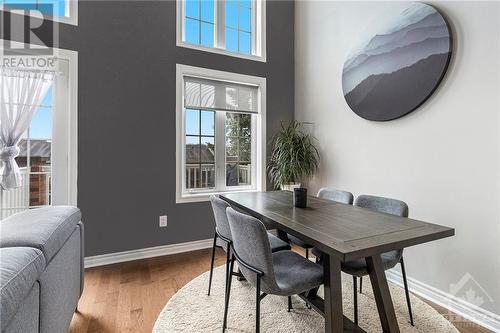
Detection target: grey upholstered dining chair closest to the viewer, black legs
<box><xmin>222</xmin><ymin>208</ymin><xmax>323</xmax><ymax>333</ymax></box>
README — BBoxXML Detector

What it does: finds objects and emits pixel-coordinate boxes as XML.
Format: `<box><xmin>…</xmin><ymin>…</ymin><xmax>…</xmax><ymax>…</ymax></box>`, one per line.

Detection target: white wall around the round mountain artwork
<box><xmin>295</xmin><ymin>1</ymin><xmax>500</xmax><ymax>314</ymax></box>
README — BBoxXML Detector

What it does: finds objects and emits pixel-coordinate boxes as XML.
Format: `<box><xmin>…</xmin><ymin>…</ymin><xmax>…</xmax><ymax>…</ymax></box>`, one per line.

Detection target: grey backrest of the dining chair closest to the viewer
<box><xmin>226</xmin><ymin>208</ymin><xmax>279</xmax><ymax>291</ymax></box>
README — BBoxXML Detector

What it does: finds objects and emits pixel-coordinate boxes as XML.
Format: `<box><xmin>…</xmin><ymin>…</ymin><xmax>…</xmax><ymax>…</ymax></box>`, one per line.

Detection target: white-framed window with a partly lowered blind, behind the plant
<box><xmin>177</xmin><ymin>65</ymin><xmax>265</xmax><ymax>202</ymax></box>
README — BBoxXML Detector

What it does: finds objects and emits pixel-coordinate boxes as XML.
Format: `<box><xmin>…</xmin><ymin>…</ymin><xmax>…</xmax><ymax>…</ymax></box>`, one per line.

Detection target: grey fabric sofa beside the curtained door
<box><xmin>0</xmin><ymin>206</ymin><xmax>83</xmax><ymax>333</ymax></box>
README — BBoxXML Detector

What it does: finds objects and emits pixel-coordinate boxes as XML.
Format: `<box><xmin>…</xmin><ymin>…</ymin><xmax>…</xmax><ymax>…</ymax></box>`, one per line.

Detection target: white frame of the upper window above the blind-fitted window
<box><xmin>176</xmin><ymin>0</ymin><xmax>267</xmax><ymax>62</ymax></box>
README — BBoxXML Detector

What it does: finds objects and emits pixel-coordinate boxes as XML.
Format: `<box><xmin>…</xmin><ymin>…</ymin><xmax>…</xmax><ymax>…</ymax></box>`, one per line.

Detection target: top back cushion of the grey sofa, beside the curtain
<box><xmin>0</xmin><ymin>206</ymin><xmax>81</xmax><ymax>264</ymax></box>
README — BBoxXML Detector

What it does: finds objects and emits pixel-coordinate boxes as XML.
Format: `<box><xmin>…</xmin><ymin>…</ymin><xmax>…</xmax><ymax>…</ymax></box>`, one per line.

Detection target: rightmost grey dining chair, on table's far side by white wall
<box><xmin>342</xmin><ymin>195</ymin><xmax>415</xmax><ymax>326</ymax></box>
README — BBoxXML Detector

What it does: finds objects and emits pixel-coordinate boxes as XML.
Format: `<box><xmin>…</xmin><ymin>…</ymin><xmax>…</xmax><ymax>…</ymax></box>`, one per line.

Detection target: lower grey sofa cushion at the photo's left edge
<box><xmin>0</xmin><ymin>247</ymin><xmax>45</xmax><ymax>332</ymax></box>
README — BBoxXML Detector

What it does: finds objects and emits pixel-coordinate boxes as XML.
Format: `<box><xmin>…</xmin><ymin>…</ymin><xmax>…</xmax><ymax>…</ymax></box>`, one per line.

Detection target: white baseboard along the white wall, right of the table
<box><xmin>386</xmin><ymin>270</ymin><xmax>500</xmax><ymax>332</ymax></box>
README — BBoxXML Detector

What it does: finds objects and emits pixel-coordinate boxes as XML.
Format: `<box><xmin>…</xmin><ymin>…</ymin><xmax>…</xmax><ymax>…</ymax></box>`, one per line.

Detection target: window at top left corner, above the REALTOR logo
<box><xmin>0</xmin><ymin>0</ymin><xmax>78</xmax><ymax>25</ymax></box>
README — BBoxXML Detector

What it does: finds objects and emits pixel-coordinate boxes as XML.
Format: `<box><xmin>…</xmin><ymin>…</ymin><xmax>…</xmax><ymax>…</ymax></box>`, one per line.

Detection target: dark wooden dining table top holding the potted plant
<box><xmin>221</xmin><ymin>191</ymin><xmax>455</xmax><ymax>261</ymax></box>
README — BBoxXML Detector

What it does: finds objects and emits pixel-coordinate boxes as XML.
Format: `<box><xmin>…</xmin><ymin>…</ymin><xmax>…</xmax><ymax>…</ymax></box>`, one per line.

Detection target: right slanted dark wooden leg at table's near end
<box><xmin>366</xmin><ymin>254</ymin><xmax>399</xmax><ymax>333</ymax></box>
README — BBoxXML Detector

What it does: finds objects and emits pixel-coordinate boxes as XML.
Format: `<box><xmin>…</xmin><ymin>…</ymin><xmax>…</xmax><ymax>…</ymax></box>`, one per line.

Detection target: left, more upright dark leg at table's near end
<box><xmin>323</xmin><ymin>254</ymin><xmax>344</xmax><ymax>333</ymax></box>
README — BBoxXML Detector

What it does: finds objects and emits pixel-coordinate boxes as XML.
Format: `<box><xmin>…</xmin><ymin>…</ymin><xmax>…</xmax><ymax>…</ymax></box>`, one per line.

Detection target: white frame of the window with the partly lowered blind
<box><xmin>175</xmin><ymin>64</ymin><xmax>266</xmax><ymax>203</ymax></box>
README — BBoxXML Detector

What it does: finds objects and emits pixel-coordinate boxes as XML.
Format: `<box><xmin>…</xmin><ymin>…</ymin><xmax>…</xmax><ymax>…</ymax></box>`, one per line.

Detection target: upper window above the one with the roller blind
<box><xmin>177</xmin><ymin>0</ymin><xmax>266</xmax><ymax>61</ymax></box>
